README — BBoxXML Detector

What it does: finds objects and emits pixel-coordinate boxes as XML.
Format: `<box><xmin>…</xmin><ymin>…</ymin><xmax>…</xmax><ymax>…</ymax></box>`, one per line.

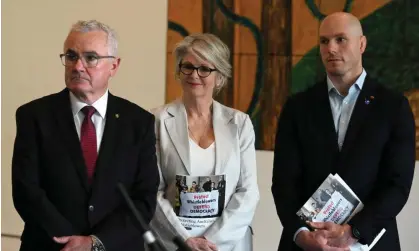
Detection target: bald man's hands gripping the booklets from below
<box><xmin>295</xmin><ymin>230</ymin><xmax>350</xmax><ymax>251</ymax></box>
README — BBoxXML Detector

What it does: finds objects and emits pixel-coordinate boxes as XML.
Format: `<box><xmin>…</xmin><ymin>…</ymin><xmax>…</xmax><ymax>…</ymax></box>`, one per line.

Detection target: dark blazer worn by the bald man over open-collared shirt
<box><xmin>272</xmin><ymin>77</ymin><xmax>415</xmax><ymax>251</ymax></box>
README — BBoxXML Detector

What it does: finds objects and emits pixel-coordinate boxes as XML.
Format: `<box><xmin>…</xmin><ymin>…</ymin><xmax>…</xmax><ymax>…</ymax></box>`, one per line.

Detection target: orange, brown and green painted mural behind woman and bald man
<box><xmin>166</xmin><ymin>0</ymin><xmax>419</xmax><ymax>157</ymax></box>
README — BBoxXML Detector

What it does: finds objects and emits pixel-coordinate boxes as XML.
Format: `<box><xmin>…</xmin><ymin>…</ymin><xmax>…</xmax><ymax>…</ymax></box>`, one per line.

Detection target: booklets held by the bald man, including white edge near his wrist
<box><xmin>297</xmin><ymin>174</ymin><xmax>385</xmax><ymax>251</ymax></box>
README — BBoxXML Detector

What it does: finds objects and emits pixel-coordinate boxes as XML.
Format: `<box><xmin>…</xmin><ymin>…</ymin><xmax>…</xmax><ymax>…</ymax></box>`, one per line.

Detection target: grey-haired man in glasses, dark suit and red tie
<box><xmin>12</xmin><ymin>20</ymin><xmax>159</xmax><ymax>251</ymax></box>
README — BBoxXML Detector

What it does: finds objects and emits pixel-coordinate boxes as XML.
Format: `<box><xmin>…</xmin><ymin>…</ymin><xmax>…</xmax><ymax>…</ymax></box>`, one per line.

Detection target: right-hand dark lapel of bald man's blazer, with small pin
<box><xmin>342</xmin><ymin>76</ymin><xmax>376</xmax><ymax>155</ymax></box>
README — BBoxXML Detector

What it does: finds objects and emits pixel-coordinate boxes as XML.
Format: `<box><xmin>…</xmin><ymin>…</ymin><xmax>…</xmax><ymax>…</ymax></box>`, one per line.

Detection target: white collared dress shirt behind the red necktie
<box><xmin>70</xmin><ymin>90</ymin><xmax>108</xmax><ymax>152</ymax></box>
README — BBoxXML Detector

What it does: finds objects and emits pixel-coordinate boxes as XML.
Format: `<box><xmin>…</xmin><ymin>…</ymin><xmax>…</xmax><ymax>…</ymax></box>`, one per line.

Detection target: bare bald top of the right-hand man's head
<box><xmin>320</xmin><ymin>12</ymin><xmax>363</xmax><ymax>36</ymax></box>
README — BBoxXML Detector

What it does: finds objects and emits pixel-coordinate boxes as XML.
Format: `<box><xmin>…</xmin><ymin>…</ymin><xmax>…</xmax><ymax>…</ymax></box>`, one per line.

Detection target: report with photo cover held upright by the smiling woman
<box><xmin>174</xmin><ymin>175</ymin><xmax>226</xmax><ymax>236</ymax></box>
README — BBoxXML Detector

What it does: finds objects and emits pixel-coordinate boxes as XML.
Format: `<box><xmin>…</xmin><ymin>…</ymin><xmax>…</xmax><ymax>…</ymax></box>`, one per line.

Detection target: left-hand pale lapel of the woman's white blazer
<box><xmin>164</xmin><ymin>101</ymin><xmax>191</xmax><ymax>174</ymax></box>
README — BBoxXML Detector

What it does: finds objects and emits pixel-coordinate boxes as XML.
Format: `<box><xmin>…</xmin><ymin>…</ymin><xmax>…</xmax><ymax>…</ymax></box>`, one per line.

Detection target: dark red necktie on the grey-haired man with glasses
<box><xmin>80</xmin><ymin>106</ymin><xmax>97</xmax><ymax>183</ymax></box>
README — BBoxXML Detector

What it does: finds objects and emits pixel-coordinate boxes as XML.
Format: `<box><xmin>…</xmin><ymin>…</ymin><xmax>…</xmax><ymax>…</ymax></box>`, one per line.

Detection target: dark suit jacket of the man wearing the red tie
<box><xmin>12</xmin><ymin>89</ymin><xmax>159</xmax><ymax>251</ymax></box>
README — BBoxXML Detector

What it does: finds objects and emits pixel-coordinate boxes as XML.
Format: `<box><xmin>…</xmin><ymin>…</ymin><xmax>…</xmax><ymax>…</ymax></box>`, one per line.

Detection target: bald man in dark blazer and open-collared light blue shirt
<box><xmin>272</xmin><ymin>13</ymin><xmax>415</xmax><ymax>251</ymax></box>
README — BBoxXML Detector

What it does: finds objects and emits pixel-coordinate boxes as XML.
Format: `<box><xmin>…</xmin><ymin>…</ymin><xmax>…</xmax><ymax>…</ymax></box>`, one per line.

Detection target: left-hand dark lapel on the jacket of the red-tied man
<box><xmin>53</xmin><ymin>89</ymin><xmax>90</xmax><ymax>191</ymax></box>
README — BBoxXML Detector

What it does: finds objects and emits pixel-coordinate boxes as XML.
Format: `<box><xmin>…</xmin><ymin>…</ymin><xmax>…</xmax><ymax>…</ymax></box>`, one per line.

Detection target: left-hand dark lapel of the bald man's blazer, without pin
<box><xmin>311</xmin><ymin>81</ymin><xmax>339</xmax><ymax>154</ymax></box>
